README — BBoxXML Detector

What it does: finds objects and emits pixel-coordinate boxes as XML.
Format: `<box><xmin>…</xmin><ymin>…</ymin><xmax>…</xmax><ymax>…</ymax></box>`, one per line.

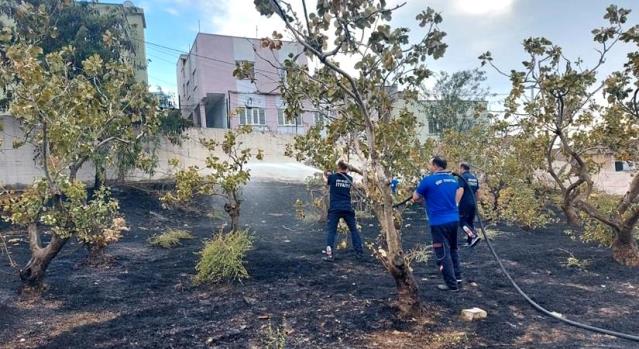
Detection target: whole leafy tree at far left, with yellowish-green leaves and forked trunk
<box><xmin>0</xmin><ymin>3</ymin><xmax>158</xmax><ymax>287</ymax></box>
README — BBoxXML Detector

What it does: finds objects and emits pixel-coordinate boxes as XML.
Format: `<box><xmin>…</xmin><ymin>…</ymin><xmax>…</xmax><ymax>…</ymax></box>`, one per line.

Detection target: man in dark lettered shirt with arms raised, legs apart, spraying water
<box><xmin>324</xmin><ymin>160</ymin><xmax>364</xmax><ymax>262</ymax></box>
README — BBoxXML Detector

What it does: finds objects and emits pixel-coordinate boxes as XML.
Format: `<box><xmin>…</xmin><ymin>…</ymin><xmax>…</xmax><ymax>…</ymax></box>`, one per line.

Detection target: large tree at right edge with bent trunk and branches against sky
<box><xmin>480</xmin><ymin>5</ymin><xmax>639</xmax><ymax>266</ymax></box>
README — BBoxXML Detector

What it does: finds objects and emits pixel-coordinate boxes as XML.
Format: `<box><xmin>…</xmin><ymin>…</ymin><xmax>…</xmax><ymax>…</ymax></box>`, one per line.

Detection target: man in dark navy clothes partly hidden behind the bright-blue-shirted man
<box><xmin>459</xmin><ymin>162</ymin><xmax>481</xmax><ymax>247</ymax></box>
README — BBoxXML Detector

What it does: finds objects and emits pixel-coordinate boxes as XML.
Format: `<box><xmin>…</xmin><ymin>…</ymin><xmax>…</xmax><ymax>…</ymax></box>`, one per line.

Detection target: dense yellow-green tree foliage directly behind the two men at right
<box><xmin>439</xmin><ymin>121</ymin><xmax>549</xmax><ymax>229</ymax></box>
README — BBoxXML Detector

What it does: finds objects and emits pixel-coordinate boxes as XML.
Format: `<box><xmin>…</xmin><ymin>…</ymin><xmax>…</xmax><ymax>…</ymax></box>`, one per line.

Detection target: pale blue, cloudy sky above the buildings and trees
<box><xmin>134</xmin><ymin>0</ymin><xmax>639</xmax><ymax>107</ymax></box>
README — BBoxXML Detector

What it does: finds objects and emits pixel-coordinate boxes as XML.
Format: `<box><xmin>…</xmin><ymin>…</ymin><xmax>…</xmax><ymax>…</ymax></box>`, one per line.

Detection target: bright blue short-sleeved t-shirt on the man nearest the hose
<box><xmin>416</xmin><ymin>172</ymin><xmax>459</xmax><ymax>226</ymax></box>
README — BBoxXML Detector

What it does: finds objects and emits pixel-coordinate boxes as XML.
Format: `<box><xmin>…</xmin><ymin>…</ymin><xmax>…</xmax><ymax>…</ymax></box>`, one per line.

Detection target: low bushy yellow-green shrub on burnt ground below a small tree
<box><xmin>195</xmin><ymin>230</ymin><xmax>253</xmax><ymax>284</ymax></box>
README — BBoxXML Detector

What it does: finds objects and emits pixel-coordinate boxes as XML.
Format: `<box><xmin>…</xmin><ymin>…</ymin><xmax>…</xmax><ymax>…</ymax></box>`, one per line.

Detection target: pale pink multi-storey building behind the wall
<box><xmin>177</xmin><ymin>33</ymin><xmax>315</xmax><ymax>134</ymax></box>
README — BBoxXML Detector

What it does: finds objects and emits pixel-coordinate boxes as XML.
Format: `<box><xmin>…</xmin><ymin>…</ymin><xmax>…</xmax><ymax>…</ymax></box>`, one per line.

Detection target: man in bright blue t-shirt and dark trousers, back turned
<box><xmin>413</xmin><ymin>156</ymin><xmax>463</xmax><ymax>291</ymax></box>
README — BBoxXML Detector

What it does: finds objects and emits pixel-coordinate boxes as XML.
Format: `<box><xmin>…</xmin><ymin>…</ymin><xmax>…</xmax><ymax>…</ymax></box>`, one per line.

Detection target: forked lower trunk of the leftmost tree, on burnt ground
<box><xmin>20</xmin><ymin>223</ymin><xmax>68</xmax><ymax>290</ymax></box>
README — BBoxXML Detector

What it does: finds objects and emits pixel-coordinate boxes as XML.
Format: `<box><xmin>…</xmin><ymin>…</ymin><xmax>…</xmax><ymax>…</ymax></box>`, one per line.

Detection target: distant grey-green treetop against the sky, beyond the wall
<box><xmin>421</xmin><ymin>69</ymin><xmax>489</xmax><ymax>135</ymax></box>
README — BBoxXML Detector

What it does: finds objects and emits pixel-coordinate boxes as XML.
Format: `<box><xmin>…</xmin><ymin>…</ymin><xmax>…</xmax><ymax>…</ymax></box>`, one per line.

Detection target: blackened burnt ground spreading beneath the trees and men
<box><xmin>0</xmin><ymin>183</ymin><xmax>639</xmax><ymax>348</ymax></box>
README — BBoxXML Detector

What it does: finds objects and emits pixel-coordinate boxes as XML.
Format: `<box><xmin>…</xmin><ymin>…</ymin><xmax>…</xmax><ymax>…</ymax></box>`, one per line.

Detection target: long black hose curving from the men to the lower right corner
<box><xmin>450</xmin><ymin>172</ymin><xmax>639</xmax><ymax>342</ymax></box>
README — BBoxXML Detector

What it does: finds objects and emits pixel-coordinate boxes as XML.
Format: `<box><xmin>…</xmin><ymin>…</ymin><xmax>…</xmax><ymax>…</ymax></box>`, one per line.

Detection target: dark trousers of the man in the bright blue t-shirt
<box><xmin>430</xmin><ymin>222</ymin><xmax>461</xmax><ymax>288</ymax></box>
